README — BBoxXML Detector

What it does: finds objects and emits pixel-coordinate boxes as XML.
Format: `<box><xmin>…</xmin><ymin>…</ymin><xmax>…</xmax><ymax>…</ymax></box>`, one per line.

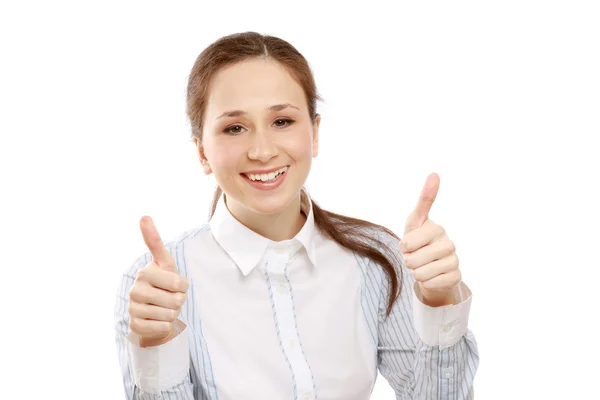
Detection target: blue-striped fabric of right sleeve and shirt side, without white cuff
<box><xmin>357</xmin><ymin>231</ymin><xmax>479</xmax><ymax>399</ymax></box>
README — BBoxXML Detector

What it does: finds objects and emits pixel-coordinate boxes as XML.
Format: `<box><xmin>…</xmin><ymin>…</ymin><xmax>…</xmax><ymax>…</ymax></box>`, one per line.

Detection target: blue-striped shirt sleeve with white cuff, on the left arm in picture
<box><xmin>115</xmin><ymin>257</ymin><xmax>194</xmax><ymax>400</ymax></box>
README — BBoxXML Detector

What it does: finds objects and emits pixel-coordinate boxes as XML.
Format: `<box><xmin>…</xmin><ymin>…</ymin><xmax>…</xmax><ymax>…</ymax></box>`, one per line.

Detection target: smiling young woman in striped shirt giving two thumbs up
<box><xmin>115</xmin><ymin>32</ymin><xmax>479</xmax><ymax>400</ymax></box>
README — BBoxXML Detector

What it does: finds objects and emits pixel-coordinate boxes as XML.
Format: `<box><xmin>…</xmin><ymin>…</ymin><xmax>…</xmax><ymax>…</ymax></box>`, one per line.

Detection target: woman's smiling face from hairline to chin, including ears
<box><xmin>196</xmin><ymin>58</ymin><xmax>320</xmax><ymax>214</ymax></box>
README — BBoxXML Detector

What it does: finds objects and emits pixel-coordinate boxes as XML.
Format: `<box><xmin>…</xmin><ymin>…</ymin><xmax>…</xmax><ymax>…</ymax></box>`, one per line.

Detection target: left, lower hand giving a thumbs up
<box><xmin>128</xmin><ymin>216</ymin><xmax>189</xmax><ymax>347</ymax></box>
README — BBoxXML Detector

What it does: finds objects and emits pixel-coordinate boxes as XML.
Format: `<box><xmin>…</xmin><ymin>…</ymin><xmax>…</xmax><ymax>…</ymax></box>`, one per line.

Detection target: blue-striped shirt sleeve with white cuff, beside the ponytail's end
<box><xmin>378</xmin><ymin>234</ymin><xmax>479</xmax><ymax>400</ymax></box>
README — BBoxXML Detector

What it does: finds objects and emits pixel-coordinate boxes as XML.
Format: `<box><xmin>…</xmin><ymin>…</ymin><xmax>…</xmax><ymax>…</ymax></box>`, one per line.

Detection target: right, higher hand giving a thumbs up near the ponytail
<box><xmin>400</xmin><ymin>173</ymin><xmax>462</xmax><ymax>307</ymax></box>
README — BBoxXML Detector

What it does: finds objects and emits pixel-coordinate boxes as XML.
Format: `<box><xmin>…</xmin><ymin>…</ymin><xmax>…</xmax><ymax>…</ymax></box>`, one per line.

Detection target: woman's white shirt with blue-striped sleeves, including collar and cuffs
<box><xmin>115</xmin><ymin>189</ymin><xmax>479</xmax><ymax>400</ymax></box>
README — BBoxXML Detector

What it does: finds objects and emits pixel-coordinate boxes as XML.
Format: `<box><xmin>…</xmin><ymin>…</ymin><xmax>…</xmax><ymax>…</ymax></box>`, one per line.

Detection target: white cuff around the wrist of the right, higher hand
<box><xmin>413</xmin><ymin>282</ymin><xmax>472</xmax><ymax>350</ymax></box>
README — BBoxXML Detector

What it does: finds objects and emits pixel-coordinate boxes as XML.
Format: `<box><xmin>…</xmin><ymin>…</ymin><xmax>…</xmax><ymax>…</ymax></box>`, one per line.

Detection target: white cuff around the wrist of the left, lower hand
<box><xmin>127</xmin><ymin>320</ymin><xmax>190</xmax><ymax>394</ymax></box>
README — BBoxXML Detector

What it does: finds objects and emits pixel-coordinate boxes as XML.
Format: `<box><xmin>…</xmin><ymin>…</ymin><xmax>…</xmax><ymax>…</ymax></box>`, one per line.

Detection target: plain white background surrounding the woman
<box><xmin>0</xmin><ymin>0</ymin><xmax>600</xmax><ymax>400</ymax></box>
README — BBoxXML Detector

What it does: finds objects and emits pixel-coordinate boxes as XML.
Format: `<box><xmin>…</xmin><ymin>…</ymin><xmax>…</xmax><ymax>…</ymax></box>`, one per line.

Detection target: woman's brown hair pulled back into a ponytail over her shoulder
<box><xmin>186</xmin><ymin>32</ymin><xmax>402</xmax><ymax>315</ymax></box>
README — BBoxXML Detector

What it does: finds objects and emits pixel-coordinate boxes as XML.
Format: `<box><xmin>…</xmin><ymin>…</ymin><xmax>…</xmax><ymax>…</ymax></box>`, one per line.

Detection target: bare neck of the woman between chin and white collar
<box><xmin>225</xmin><ymin>193</ymin><xmax>306</xmax><ymax>242</ymax></box>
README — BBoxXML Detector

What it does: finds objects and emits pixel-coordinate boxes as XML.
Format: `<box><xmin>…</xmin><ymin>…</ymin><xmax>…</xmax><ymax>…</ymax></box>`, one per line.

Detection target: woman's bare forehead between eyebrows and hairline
<box><xmin>207</xmin><ymin>58</ymin><xmax>306</xmax><ymax>118</ymax></box>
